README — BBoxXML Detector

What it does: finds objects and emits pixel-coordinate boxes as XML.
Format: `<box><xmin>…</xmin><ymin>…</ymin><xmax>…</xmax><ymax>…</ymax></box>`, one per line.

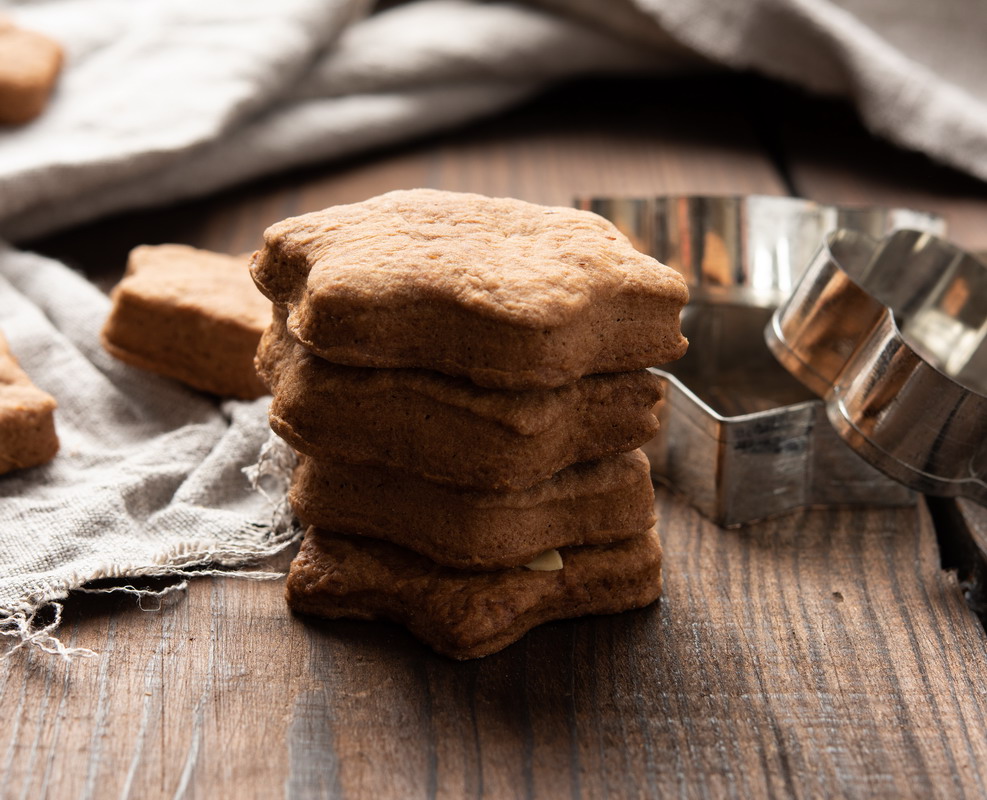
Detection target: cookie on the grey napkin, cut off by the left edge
<box><xmin>0</xmin><ymin>334</ymin><xmax>58</xmax><ymax>474</ymax></box>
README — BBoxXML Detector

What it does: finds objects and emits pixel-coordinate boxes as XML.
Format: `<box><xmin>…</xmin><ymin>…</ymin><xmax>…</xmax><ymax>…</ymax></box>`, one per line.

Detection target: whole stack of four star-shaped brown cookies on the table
<box><xmin>252</xmin><ymin>189</ymin><xmax>687</xmax><ymax>658</ymax></box>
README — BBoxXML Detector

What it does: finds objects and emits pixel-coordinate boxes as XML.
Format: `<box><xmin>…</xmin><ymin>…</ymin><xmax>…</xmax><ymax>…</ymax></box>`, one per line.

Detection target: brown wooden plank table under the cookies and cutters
<box><xmin>0</xmin><ymin>78</ymin><xmax>987</xmax><ymax>798</ymax></box>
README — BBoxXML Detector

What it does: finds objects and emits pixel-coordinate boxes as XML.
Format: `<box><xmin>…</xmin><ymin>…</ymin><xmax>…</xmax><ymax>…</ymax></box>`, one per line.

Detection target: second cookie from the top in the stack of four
<box><xmin>257</xmin><ymin>307</ymin><xmax>661</xmax><ymax>489</ymax></box>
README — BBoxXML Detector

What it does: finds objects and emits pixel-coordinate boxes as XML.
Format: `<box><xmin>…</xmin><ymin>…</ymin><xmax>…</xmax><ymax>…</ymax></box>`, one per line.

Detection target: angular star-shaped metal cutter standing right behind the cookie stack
<box><xmin>644</xmin><ymin>304</ymin><xmax>914</xmax><ymax>527</ymax></box>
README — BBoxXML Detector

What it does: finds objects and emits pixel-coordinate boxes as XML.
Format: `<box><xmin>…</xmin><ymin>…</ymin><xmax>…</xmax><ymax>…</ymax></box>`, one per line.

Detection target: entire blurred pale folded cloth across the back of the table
<box><xmin>0</xmin><ymin>0</ymin><xmax>987</xmax><ymax>240</ymax></box>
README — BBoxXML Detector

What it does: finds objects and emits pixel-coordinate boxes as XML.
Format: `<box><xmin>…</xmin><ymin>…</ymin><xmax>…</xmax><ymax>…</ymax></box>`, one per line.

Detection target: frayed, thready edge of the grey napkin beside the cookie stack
<box><xmin>0</xmin><ymin>434</ymin><xmax>301</xmax><ymax>662</ymax></box>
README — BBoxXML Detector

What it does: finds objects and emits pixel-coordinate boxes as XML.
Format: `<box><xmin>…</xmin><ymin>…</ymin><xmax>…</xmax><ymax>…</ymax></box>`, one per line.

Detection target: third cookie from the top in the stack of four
<box><xmin>288</xmin><ymin>450</ymin><xmax>655</xmax><ymax>569</ymax></box>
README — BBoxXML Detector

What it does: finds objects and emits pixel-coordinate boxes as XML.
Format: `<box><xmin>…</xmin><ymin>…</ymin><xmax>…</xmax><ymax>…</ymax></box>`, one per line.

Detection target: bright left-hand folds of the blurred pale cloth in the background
<box><xmin>0</xmin><ymin>0</ymin><xmax>674</xmax><ymax>240</ymax></box>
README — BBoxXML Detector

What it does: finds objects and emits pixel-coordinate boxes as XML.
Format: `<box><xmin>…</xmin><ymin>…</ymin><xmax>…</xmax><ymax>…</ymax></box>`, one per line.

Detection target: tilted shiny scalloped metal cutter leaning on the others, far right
<box><xmin>766</xmin><ymin>230</ymin><xmax>987</xmax><ymax>504</ymax></box>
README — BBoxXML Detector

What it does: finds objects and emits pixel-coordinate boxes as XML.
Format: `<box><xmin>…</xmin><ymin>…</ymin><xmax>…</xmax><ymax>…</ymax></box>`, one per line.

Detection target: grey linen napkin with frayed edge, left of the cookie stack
<box><xmin>0</xmin><ymin>246</ymin><xmax>293</xmax><ymax>655</ymax></box>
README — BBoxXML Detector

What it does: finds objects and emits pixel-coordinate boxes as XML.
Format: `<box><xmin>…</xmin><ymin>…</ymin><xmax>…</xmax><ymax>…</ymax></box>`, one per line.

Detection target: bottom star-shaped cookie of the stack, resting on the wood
<box><xmin>287</xmin><ymin>528</ymin><xmax>661</xmax><ymax>659</ymax></box>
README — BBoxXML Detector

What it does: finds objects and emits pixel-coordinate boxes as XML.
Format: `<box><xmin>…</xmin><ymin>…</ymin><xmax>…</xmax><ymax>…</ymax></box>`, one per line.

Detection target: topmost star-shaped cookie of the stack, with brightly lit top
<box><xmin>251</xmin><ymin>189</ymin><xmax>688</xmax><ymax>390</ymax></box>
